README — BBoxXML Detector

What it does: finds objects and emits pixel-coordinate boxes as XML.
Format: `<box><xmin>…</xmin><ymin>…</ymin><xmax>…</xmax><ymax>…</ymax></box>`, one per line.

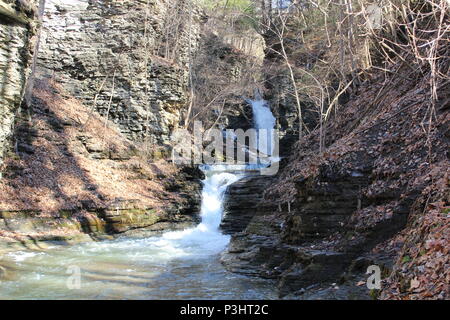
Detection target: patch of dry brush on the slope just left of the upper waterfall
<box><xmin>189</xmin><ymin>30</ymin><xmax>261</xmax><ymax>127</ymax></box>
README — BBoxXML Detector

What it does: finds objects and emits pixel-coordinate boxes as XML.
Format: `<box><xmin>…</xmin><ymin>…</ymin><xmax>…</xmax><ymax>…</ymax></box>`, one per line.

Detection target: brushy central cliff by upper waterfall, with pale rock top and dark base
<box><xmin>188</xmin><ymin>17</ymin><xmax>265</xmax><ymax>130</ymax></box>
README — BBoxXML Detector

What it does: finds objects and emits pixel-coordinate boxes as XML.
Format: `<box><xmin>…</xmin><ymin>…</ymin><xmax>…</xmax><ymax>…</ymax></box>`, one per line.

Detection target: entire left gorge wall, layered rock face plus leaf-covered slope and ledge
<box><xmin>0</xmin><ymin>0</ymin><xmax>207</xmax><ymax>246</ymax></box>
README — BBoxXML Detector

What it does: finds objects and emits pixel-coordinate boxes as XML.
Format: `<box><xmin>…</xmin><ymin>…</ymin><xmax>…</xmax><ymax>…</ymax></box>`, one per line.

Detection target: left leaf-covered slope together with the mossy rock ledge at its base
<box><xmin>0</xmin><ymin>80</ymin><xmax>201</xmax><ymax>250</ymax></box>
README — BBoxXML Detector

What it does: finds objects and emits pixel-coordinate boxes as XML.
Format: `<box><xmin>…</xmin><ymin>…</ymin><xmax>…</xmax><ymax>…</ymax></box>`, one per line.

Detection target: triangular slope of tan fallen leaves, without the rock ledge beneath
<box><xmin>0</xmin><ymin>81</ymin><xmax>188</xmax><ymax>214</ymax></box>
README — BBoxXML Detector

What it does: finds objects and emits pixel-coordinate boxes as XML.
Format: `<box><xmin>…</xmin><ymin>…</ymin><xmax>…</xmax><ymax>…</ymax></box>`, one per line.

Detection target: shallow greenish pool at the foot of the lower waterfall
<box><xmin>0</xmin><ymin>238</ymin><xmax>276</xmax><ymax>299</ymax></box>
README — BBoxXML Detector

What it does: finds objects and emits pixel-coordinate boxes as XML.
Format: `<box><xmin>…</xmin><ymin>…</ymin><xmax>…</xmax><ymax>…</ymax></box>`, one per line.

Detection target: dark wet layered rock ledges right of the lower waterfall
<box><xmin>221</xmin><ymin>154</ymin><xmax>404</xmax><ymax>299</ymax></box>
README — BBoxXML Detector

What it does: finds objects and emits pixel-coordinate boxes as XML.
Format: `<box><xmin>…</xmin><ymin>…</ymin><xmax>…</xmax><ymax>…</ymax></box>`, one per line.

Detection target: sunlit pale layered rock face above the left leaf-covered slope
<box><xmin>38</xmin><ymin>0</ymin><xmax>206</xmax><ymax>144</ymax></box>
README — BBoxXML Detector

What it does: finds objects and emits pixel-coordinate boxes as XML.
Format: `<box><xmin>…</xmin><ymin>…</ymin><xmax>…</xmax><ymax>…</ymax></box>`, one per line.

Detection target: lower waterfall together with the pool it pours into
<box><xmin>0</xmin><ymin>172</ymin><xmax>276</xmax><ymax>299</ymax></box>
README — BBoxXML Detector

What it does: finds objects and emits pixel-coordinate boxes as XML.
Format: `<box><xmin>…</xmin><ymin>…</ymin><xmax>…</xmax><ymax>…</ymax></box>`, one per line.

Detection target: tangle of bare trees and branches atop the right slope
<box><xmin>261</xmin><ymin>0</ymin><xmax>450</xmax><ymax>152</ymax></box>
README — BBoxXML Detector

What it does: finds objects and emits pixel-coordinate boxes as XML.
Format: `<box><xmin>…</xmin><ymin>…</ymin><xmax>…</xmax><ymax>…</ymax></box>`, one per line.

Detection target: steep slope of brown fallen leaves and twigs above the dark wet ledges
<box><xmin>266</xmin><ymin>1</ymin><xmax>450</xmax><ymax>299</ymax></box>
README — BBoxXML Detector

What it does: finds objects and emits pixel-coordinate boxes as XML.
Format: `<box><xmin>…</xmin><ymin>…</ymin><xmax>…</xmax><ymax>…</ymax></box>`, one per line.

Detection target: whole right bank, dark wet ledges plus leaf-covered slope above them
<box><xmin>222</xmin><ymin>56</ymin><xmax>450</xmax><ymax>299</ymax></box>
